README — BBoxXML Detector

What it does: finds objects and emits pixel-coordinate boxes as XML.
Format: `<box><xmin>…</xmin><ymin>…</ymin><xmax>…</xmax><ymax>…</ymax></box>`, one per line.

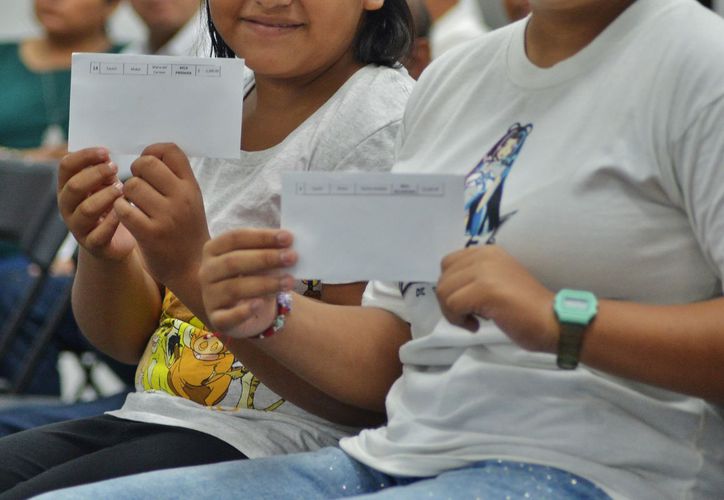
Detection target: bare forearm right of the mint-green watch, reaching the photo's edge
<box><xmin>581</xmin><ymin>298</ymin><xmax>724</xmax><ymax>403</ymax></box>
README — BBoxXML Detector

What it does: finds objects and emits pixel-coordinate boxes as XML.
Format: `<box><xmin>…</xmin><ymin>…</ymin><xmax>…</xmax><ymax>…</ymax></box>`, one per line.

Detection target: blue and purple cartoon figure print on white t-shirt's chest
<box><xmin>465</xmin><ymin>123</ymin><xmax>533</xmax><ymax>246</ymax></box>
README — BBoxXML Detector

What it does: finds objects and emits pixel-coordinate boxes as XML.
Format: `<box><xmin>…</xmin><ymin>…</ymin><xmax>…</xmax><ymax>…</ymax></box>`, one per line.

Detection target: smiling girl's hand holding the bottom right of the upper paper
<box><xmin>114</xmin><ymin>144</ymin><xmax>209</xmax><ymax>286</ymax></box>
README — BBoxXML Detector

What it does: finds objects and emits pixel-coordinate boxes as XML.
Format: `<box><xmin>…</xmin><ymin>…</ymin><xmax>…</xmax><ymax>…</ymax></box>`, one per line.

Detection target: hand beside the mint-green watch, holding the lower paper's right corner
<box><xmin>437</xmin><ymin>245</ymin><xmax>558</xmax><ymax>353</ymax></box>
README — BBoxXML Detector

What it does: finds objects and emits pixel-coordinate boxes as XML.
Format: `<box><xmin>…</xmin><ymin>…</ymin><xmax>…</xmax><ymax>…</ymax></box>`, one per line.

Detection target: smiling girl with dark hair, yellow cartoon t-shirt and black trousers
<box><xmin>0</xmin><ymin>0</ymin><xmax>412</xmax><ymax>498</ymax></box>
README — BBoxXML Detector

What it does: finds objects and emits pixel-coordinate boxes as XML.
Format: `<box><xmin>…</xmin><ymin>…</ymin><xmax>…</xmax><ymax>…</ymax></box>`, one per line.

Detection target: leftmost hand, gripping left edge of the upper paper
<box><xmin>58</xmin><ymin>148</ymin><xmax>136</xmax><ymax>260</ymax></box>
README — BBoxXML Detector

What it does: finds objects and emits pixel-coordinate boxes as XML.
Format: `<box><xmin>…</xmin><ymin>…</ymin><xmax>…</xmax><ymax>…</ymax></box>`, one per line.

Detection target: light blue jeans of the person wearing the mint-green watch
<box><xmin>38</xmin><ymin>448</ymin><xmax>609</xmax><ymax>500</ymax></box>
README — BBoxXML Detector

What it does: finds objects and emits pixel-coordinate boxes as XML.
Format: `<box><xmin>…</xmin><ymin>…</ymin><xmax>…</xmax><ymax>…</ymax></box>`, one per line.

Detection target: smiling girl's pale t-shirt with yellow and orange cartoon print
<box><xmin>111</xmin><ymin>65</ymin><xmax>414</xmax><ymax>457</ymax></box>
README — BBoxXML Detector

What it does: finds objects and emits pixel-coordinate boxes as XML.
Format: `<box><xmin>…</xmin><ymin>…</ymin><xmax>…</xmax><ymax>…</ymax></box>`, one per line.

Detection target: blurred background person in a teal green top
<box><xmin>0</xmin><ymin>0</ymin><xmax>121</xmax><ymax>160</ymax></box>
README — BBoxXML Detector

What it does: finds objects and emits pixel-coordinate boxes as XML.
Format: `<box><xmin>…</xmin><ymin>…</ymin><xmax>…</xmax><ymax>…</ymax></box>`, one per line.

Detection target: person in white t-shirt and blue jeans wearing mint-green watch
<box><xmin>43</xmin><ymin>0</ymin><xmax>724</xmax><ymax>500</ymax></box>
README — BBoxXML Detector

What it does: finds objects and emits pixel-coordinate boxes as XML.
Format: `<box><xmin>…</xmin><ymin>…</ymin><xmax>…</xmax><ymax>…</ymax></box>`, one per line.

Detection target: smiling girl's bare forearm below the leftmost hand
<box><xmin>72</xmin><ymin>249</ymin><xmax>161</xmax><ymax>363</ymax></box>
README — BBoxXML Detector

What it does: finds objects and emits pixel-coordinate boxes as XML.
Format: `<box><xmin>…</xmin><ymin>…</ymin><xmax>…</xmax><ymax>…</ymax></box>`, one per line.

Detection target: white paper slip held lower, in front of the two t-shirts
<box><xmin>281</xmin><ymin>172</ymin><xmax>465</xmax><ymax>283</ymax></box>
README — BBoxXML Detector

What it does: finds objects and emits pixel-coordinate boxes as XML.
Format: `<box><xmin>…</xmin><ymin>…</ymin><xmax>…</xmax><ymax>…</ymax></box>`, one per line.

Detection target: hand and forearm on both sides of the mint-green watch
<box><xmin>437</xmin><ymin>246</ymin><xmax>724</xmax><ymax>402</ymax></box>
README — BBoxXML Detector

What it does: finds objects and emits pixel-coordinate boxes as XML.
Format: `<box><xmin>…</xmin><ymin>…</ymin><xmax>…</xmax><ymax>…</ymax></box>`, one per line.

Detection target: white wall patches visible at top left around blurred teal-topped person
<box><xmin>0</xmin><ymin>0</ymin><xmax>144</xmax><ymax>41</ymax></box>
